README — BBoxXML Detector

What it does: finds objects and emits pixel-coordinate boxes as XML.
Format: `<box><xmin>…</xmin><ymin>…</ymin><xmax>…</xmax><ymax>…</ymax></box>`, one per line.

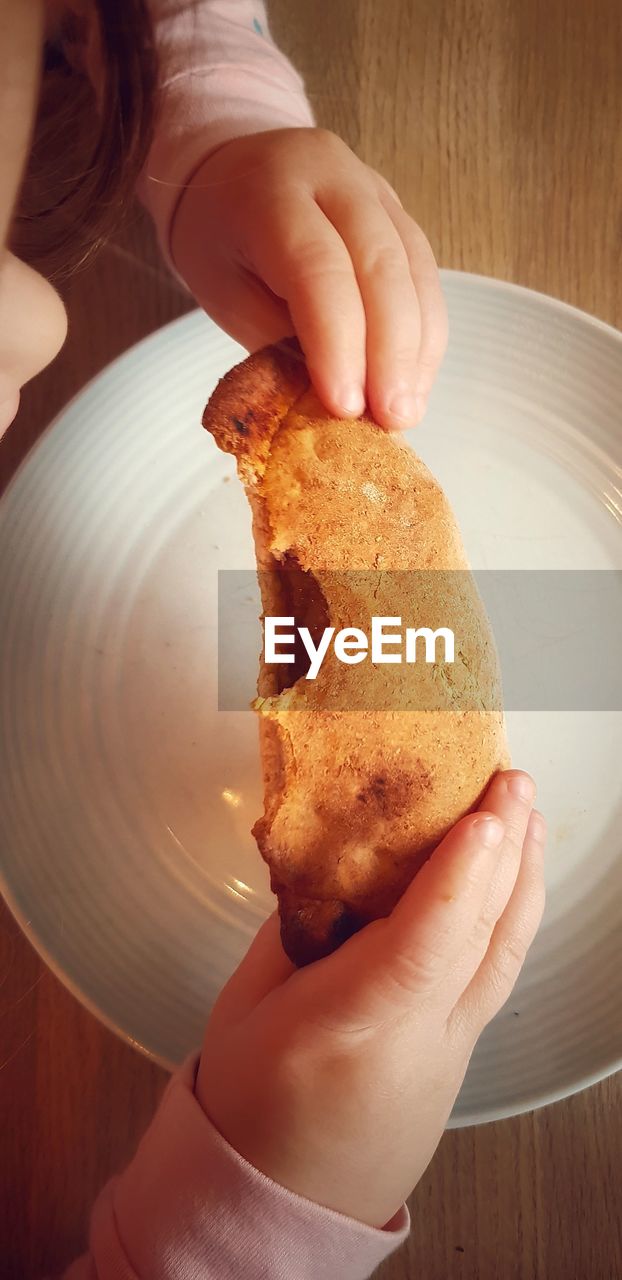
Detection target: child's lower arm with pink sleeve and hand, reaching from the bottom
<box><xmin>58</xmin><ymin>772</ymin><xmax>544</xmax><ymax>1280</ymax></box>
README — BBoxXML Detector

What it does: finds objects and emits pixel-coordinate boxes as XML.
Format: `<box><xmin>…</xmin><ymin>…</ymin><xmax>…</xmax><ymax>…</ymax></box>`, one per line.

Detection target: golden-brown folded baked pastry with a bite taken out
<box><xmin>203</xmin><ymin>342</ymin><xmax>509</xmax><ymax>965</ymax></box>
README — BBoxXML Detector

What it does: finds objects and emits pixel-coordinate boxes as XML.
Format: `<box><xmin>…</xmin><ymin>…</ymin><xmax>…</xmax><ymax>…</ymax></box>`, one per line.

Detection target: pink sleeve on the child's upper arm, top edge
<box><xmin>140</xmin><ymin>0</ymin><xmax>314</xmax><ymax>252</ymax></box>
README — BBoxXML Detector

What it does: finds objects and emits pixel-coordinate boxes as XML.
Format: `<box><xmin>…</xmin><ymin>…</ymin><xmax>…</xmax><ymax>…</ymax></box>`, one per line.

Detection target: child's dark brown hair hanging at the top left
<box><xmin>12</xmin><ymin>0</ymin><xmax>157</xmax><ymax>280</ymax></box>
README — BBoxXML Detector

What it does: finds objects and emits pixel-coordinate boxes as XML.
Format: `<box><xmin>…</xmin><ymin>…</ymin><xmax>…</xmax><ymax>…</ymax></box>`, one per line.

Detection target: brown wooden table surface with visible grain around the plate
<box><xmin>0</xmin><ymin>0</ymin><xmax>622</xmax><ymax>1280</ymax></box>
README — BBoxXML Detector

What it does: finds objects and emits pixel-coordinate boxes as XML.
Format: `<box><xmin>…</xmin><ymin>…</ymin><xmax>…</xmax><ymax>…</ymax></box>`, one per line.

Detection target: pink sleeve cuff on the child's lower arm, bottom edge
<box><xmin>65</xmin><ymin>1060</ymin><xmax>408</xmax><ymax>1280</ymax></box>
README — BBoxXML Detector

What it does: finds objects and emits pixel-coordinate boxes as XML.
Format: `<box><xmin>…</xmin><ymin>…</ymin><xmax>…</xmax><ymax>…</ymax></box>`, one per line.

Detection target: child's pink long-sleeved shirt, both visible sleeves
<box><xmin>52</xmin><ymin>0</ymin><xmax>410</xmax><ymax>1280</ymax></box>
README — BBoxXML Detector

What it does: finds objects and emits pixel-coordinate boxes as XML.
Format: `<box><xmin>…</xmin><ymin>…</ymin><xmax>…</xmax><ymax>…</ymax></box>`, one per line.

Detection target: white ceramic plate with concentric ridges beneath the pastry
<box><xmin>0</xmin><ymin>273</ymin><xmax>622</xmax><ymax>1124</ymax></box>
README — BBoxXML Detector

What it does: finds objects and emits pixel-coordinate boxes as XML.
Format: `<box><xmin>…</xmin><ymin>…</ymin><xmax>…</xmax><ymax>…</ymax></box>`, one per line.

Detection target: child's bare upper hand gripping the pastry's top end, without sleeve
<box><xmin>171</xmin><ymin>129</ymin><xmax>447</xmax><ymax>429</ymax></box>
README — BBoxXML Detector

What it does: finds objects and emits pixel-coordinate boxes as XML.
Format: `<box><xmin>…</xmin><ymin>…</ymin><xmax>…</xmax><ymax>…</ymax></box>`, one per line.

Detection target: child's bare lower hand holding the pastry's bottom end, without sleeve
<box><xmin>196</xmin><ymin>772</ymin><xmax>544</xmax><ymax>1226</ymax></box>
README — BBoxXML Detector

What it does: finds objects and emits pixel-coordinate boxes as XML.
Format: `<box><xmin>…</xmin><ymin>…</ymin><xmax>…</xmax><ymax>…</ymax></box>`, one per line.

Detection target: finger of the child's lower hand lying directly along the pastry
<box><xmin>299</xmin><ymin>813</ymin><xmax>504</xmax><ymax>1032</ymax></box>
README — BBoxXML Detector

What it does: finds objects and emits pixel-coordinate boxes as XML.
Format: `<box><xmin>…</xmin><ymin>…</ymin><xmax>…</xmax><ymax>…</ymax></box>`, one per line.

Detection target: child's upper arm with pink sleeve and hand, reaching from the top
<box><xmin>135</xmin><ymin>0</ymin><xmax>447</xmax><ymax>429</ymax></box>
